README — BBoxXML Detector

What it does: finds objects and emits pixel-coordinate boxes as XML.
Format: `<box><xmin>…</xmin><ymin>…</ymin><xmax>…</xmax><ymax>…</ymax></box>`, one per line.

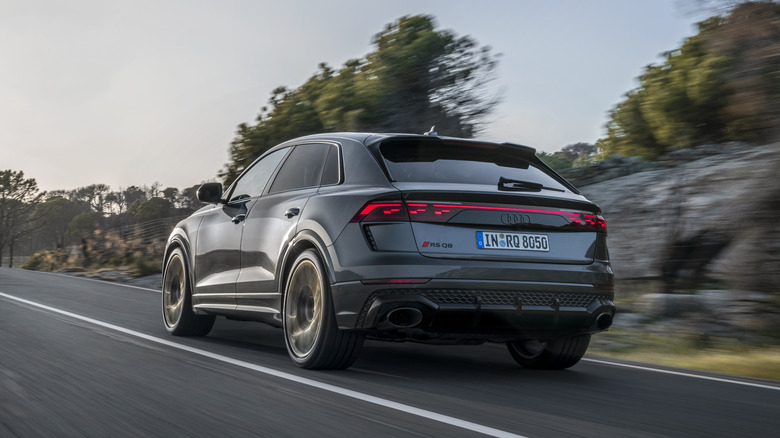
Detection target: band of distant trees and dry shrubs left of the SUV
<box><xmin>0</xmin><ymin>179</ymin><xmax>201</xmax><ymax>273</ymax></box>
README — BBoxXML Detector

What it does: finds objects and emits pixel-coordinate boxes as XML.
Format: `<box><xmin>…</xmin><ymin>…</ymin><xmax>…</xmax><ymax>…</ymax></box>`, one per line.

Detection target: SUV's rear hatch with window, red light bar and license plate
<box><xmin>366</xmin><ymin>137</ymin><xmax>606</xmax><ymax>264</ymax></box>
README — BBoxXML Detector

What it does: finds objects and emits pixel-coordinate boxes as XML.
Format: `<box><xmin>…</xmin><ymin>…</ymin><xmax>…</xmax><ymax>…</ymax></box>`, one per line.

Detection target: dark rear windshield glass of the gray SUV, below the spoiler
<box><xmin>379</xmin><ymin>140</ymin><xmax>567</xmax><ymax>190</ymax></box>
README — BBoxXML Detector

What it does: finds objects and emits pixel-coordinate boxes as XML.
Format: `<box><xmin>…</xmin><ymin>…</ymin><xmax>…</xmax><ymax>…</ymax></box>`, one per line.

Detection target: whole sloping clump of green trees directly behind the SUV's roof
<box><xmin>219</xmin><ymin>16</ymin><xmax>499</xmax><ymax>185</ymax></box>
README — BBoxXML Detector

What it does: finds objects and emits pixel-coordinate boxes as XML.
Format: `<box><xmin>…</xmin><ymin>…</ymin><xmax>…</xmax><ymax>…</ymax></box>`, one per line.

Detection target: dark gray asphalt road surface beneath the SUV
<box><xmin>0</xmin><ymin>268</ymin><xmax>780</xmax><ymax>438</ymax></box>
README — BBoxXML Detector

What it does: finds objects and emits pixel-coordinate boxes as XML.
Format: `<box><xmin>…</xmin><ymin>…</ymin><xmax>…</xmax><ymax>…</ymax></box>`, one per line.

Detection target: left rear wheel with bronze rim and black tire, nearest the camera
<box><xmin>282</xmin><ymin>249</ymin><xmax>363</xmax><ymax>370</ymax></box>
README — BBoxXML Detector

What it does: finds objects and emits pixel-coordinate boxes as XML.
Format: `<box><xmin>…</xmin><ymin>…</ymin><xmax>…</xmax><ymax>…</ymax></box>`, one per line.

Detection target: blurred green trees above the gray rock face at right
<box><xmin>596</xmin><ymin>1</ymin><xmax>780</xmax><ymax>159</ymax></box>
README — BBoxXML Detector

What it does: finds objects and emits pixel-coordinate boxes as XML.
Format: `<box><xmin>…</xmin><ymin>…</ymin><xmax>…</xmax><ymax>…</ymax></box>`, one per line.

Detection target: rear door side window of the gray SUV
<box><xmin>268</xmin><ymin>143</ymin><xmax>330</xmax><ymax>193</ymax></box>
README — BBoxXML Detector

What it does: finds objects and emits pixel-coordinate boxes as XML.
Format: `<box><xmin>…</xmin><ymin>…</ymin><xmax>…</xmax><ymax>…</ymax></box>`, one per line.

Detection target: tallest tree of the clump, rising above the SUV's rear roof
<box><xmin>363</xmin><ymin>16</ymin><xmax>498</xmax><ymax>137</ymax></box>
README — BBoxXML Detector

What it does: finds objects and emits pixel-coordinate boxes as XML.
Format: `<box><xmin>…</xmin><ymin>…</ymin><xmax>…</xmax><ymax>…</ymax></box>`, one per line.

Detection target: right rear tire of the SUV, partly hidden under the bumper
<box><xmin>506</xmin><ymin>335</ymin><xmax>590</xmax><ymax>370</ymax></box>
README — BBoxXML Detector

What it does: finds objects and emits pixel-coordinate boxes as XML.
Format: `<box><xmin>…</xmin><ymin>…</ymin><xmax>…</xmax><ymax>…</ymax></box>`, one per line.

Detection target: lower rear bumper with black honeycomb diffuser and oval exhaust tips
<box><xmin>332</xmin><ymin>280</ymin><xmax>615</xmax><ymax>342</ymax></box>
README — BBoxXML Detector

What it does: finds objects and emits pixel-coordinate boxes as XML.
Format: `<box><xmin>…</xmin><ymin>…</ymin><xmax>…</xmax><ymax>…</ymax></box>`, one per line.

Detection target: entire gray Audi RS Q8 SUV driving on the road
<box><xmin>162</xmin><ymin>133</ymin><xmax>615</xmax><ymax>369</ymax></box>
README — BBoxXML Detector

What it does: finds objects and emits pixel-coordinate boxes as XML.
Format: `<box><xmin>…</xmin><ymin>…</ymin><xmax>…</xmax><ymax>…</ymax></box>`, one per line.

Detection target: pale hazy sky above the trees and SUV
<box><xmin>0</xmin><ymin>0</ymin><xmax>707</xmax><ymax>190</ymax></box>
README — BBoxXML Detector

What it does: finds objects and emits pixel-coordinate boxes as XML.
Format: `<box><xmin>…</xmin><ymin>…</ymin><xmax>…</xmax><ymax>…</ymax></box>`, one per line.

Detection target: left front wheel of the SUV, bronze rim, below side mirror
<box><xmin>162</xmin><ymin>248</ymin><xmax>216</xmax><ymax>336</ymax></box>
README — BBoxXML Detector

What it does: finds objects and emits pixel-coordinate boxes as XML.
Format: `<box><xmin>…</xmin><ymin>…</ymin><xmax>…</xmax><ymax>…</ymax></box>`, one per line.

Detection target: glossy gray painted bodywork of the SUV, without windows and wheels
<box><xmin>166</xmin><ymin>133</ymin><xmax>614</xmax><ymax>366</ymax></box>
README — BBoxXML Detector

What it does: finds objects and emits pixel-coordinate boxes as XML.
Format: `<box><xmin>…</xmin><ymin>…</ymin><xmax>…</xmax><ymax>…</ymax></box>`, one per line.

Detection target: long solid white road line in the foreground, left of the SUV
<box><xmin>0</xmin><ymin>292</ymin><xmax>525</xmax><ymax>438</ymax></box>
